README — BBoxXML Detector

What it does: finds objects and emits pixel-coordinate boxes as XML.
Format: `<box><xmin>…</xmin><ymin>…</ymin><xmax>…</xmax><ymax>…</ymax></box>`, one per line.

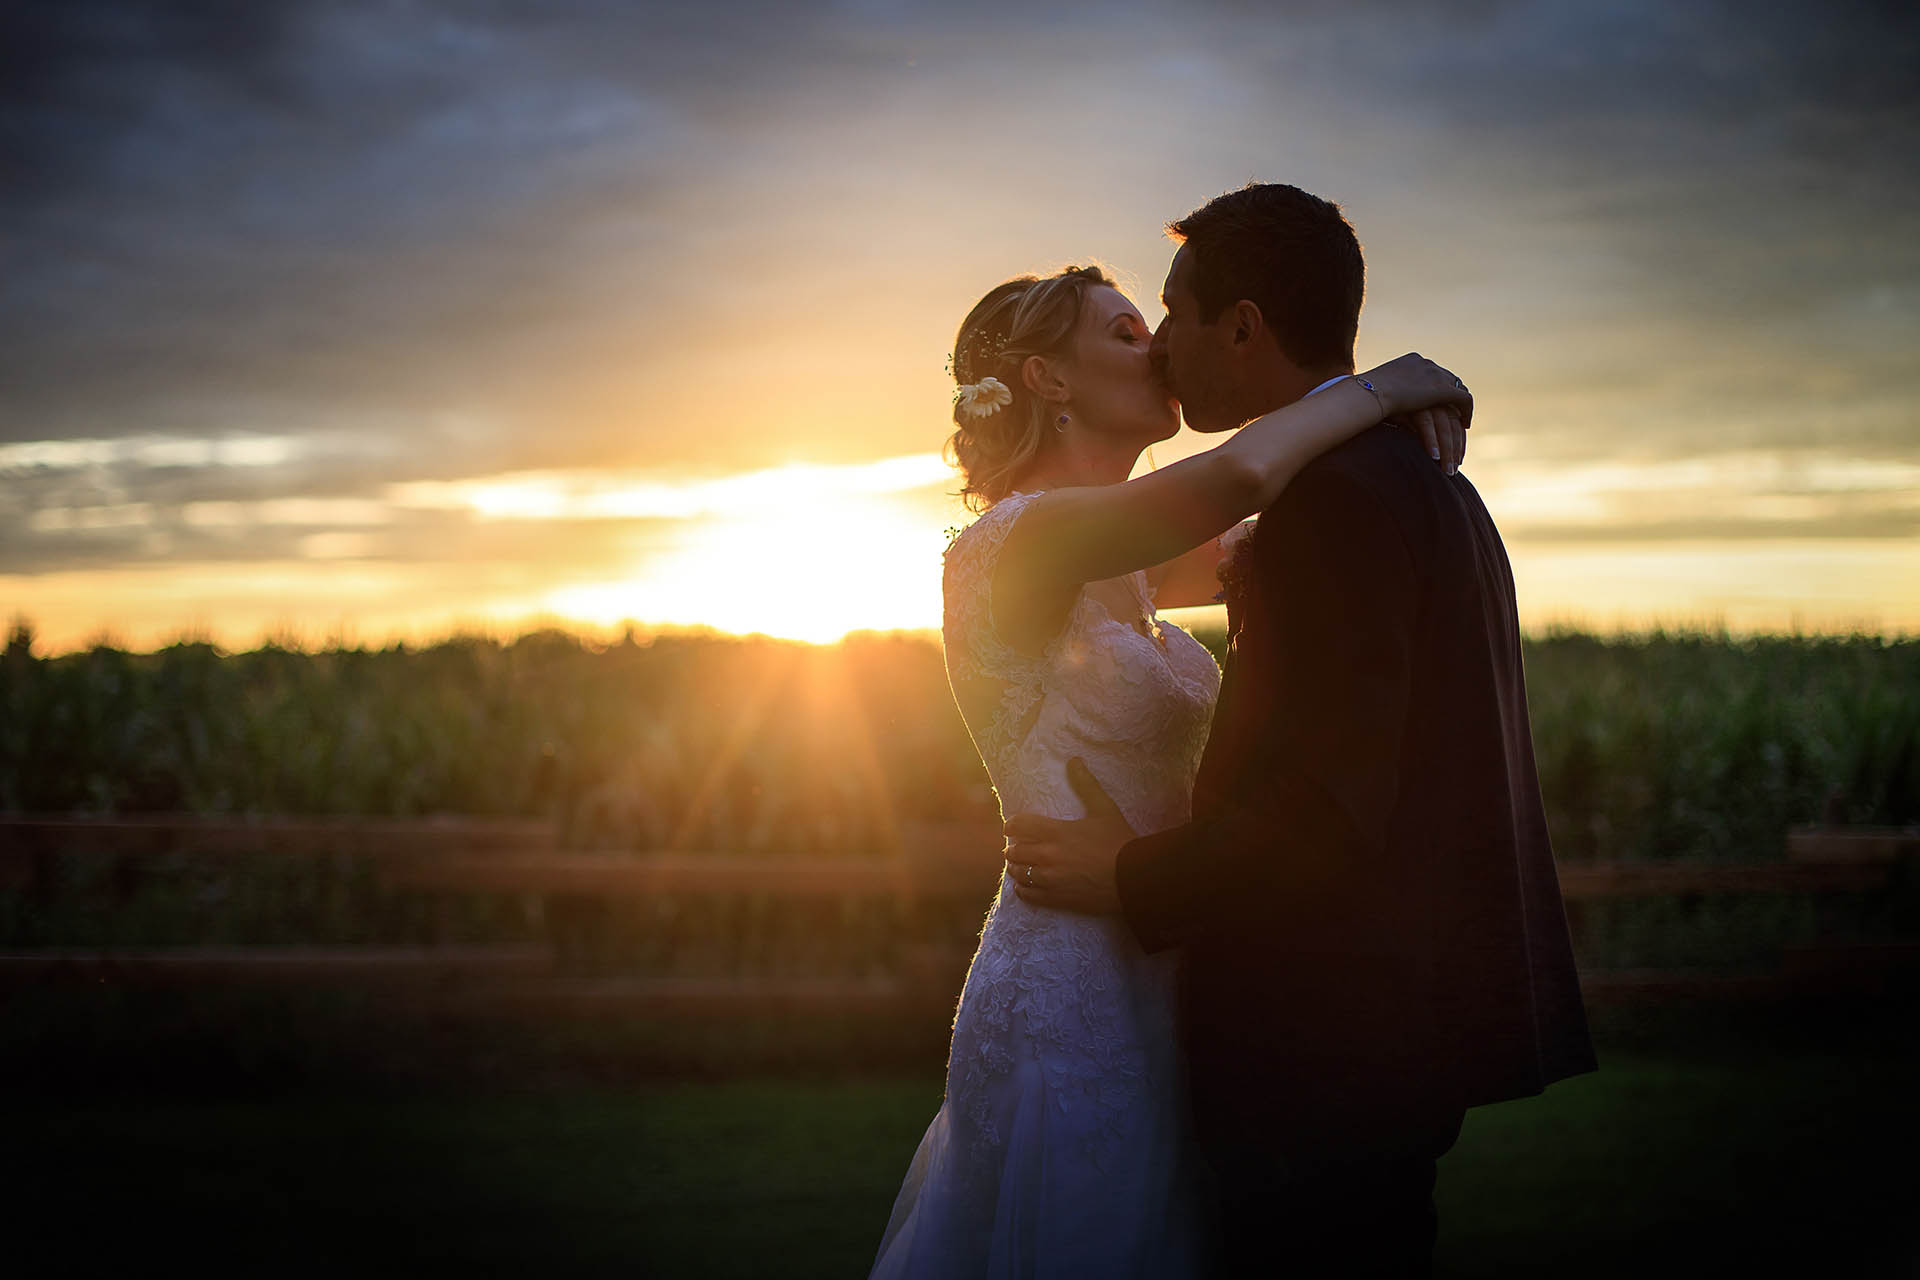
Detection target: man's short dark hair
<box><xmin>1167</xmin><ymin>182</ymin><xmax>1367</xmax><ymax>368</ymax></box>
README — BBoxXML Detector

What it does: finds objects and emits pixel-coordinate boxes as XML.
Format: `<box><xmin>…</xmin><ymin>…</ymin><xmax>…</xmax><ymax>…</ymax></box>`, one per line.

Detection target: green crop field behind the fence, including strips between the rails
<box><xmin>0</xmin><ymin>626</ymin><xmax>1920</xmax><ymax>971</ymax></box>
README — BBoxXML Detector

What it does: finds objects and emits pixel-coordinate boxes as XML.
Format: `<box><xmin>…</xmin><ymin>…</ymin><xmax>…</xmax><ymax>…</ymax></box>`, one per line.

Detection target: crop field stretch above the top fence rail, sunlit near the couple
<box><xmin>0</xmin><ymin>624</ymin><xmax>1920</xmax><ymax>860</ymax></box>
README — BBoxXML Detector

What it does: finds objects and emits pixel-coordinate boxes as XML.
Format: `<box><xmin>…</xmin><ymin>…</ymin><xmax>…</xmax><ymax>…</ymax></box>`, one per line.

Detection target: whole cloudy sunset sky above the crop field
<box><xmin>0</xmin><ymin>0</ymin><xmax>1920</xmax><ymax>649</ymax></box>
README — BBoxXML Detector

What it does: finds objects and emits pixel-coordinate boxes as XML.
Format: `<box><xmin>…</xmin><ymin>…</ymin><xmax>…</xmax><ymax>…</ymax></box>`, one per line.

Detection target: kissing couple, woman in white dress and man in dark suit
<box><xmin>872</xmin><ymin>184</ymin><xmax>1594</xmax><ymax>1280</ymax></box>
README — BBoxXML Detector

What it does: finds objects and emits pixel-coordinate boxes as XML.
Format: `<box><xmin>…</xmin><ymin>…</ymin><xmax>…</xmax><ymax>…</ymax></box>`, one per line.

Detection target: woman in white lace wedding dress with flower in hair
<box><xmin>872</xmin><ymin>267</ymin><xmax>1465</xmax><ymax>1278</ymax></box>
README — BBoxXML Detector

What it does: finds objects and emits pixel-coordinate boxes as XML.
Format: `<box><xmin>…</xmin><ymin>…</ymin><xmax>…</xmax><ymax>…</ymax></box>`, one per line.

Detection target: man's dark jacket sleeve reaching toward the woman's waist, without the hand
<box><xmin>1114</xmin><ymin>464</ymin><xmax>1419</xmax><ymax>950</ymax></box>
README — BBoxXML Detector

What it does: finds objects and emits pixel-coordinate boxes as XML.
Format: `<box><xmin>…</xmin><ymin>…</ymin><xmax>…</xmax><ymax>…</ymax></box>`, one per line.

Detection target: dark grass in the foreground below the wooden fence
<box><xmin>0</xmin><ymin>1011</ymin><xmax>1920</xmax><ymax>1278</ymax></box>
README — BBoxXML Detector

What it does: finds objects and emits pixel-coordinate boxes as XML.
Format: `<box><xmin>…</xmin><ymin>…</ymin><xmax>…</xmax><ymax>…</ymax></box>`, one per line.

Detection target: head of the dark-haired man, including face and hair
<box><xmin>1152</xmin><ymin>182</ymin><xmax>1367</xmax><ymax>432</ymax></box>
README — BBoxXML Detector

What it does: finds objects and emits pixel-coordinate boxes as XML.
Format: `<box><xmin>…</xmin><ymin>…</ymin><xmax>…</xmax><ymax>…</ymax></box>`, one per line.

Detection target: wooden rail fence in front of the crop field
<box><xmin>0</xmin><ymin>816</ymin><xmax>1920</xmax><ymax>1017</ymax></box>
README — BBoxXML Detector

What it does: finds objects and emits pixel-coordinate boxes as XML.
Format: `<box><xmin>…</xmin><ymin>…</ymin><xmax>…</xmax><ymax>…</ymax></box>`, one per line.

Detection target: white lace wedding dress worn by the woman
<box><xmin>872</xmin><ymin>493</ymin><xmax>1219</xmax><ymax>1280</ymax></box>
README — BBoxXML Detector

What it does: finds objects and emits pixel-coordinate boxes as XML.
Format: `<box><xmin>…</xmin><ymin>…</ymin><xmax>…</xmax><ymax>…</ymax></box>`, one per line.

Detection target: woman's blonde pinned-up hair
<box><xmin>947</xmin><ymin>267</ymin><xmax>1114</xmax><ymax>510</ymax></box>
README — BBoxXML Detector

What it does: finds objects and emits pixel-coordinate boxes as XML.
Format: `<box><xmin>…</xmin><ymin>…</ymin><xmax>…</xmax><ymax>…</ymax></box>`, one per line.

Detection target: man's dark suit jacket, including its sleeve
<box><xmin>1117</xmin><ymin>426</ymin><xmax>1594</xmax><ymax>1151</ymax></box>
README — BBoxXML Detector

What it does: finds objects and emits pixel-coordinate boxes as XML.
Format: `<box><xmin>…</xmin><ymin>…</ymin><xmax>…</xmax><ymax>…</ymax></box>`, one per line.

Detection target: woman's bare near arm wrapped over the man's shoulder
<box><xmin>991</xmin><ymin>355</ymin><xmax>1473</xmax><ymax>651</ymax></box>
